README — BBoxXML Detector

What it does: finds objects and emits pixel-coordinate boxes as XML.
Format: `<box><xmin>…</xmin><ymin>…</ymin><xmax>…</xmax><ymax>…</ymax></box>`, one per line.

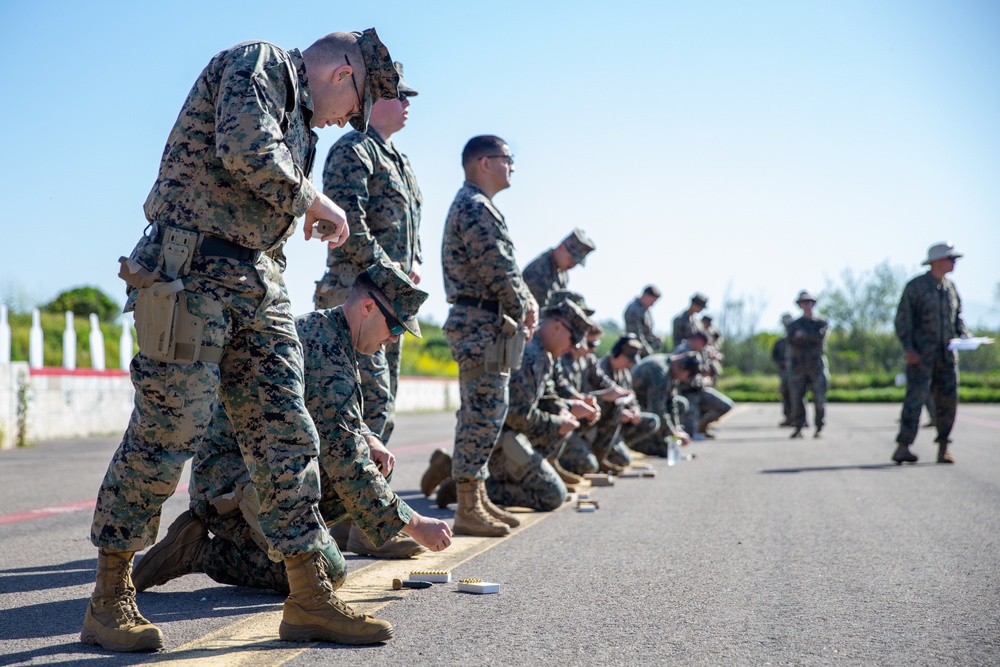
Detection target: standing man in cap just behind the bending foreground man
<box><xmin>313</xmin><ymin>62</ymin><xmax>423</xmax><ymax>443</ymax></box>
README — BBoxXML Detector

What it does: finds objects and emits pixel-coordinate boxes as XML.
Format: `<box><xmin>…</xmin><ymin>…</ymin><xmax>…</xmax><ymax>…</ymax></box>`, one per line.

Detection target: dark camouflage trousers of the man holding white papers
<box><xmin>896</xmin><ymin>359</ymin><xmax>958</xmax><ymax>445</ymax></box>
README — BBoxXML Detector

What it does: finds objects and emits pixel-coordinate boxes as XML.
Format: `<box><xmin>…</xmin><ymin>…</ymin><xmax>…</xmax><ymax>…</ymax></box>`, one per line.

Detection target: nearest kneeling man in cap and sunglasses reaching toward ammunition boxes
<box><xmin>143</xmin><ymin>260</ymin><xmax>441</xmax><ymax>593</ymax></box>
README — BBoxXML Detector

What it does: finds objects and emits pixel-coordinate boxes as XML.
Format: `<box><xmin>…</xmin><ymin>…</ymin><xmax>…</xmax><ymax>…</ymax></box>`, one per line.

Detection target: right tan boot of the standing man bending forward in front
<box><xmin>278</xmin><ymin>551</ymin><xmax>392</xmax><ymax>645</ymax></box>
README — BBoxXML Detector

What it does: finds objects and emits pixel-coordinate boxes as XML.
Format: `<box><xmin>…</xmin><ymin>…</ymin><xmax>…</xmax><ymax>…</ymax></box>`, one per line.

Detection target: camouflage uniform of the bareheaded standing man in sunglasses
<box><xmin>441</xmin><ymin>181</ymin><xmax>531</xmax><ymax>483</ymax></box>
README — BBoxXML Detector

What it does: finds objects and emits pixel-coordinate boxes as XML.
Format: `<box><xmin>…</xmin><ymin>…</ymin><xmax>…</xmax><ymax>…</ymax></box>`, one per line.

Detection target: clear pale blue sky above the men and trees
<box><xmin>0</xmin><ymin>0</ymin><xmax>1000</xmax><ymax>329</ymax></box>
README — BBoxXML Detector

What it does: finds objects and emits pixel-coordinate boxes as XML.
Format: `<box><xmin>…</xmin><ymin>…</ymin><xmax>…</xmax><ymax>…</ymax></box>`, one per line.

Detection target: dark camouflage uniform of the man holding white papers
<box><xmin>896</xmin><ymin>272</ymin><xmax>970</xmax><ymax>445</ymax></box>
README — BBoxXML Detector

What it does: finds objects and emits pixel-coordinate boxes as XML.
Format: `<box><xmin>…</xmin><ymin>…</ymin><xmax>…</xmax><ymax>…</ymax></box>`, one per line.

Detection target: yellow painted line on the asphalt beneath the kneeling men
<box><xmin>150</xmin><ymin>503</ymin><xmax>572</xmax><ymax>667</ymax></box>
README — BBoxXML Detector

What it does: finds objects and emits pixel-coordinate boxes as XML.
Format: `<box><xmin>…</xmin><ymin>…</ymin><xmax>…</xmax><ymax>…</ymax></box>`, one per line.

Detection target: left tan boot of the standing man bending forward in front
<box><xmin>80</xmin><ymin>549</ymin><xmax>163</xmax><ymax>652</ymax></box>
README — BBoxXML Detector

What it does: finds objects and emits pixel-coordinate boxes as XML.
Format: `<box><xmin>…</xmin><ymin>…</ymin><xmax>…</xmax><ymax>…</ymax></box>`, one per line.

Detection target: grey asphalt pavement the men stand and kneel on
<box><xmin>0</xmin><ymin>404</ymin><xmax>1000</xmax><ymax>667</ymax></box>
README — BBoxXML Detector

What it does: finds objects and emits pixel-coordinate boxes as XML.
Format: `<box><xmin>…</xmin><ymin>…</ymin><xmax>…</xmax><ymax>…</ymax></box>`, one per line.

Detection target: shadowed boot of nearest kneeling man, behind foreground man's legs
<box><xmin>132</xmin><ymin>510</ymin><xmax>212</xmax><ymax>593</ymax></box>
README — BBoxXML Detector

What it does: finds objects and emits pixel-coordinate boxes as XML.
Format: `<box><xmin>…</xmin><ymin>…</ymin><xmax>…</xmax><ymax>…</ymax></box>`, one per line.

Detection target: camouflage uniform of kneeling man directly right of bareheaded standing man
<box><xmin>486</xmin><ymin>335</ymin><xmax>568</xmax><ymax>511</ymax></box>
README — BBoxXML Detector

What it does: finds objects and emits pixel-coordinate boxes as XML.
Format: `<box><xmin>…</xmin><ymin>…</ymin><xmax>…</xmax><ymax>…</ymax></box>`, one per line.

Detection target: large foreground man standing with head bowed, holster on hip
<box><xmin>81</xmin><ymin>29</ymin><xmax>397</xmax><ymax>651</ymax></box>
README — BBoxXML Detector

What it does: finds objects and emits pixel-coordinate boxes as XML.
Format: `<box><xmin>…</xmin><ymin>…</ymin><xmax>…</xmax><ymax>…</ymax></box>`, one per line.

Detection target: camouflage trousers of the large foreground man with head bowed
<box><xmin>91</xmin><ymin>256</ymin><xmax>332</xmax><ymax>558</ymax></box>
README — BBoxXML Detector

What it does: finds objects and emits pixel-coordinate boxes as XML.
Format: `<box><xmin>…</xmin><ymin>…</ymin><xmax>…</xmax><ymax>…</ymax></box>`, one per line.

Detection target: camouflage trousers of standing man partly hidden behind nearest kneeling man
<box><xmin>313</xmin><ymin>288</ymin><xmax>403</xmax><ymax>445</ymax></box>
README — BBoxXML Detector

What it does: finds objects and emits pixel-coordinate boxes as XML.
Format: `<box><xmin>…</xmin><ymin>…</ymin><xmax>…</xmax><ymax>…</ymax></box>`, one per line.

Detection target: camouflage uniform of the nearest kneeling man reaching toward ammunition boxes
<box><xmin>190</xmin><ymin>306</ymin><xmax>413</xmax><ymax>592</ymax></box>
